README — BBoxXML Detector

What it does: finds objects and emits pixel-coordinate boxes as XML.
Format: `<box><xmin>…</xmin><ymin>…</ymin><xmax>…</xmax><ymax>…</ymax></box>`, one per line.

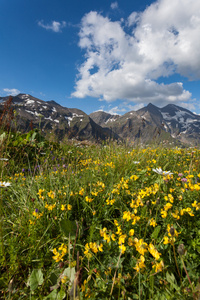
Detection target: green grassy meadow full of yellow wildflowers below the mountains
<box><xmin>0</xmin><ymin>133</ymin><xmax>200</xmax><ymax>300</ymax></box>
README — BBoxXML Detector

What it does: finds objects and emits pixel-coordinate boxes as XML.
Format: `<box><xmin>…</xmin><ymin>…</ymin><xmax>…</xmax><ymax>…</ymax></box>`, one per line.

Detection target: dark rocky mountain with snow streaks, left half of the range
<box><xmin>0</xmin><ymin>94</ymin><xmax>119</xmax><ymax>141</ymax></box>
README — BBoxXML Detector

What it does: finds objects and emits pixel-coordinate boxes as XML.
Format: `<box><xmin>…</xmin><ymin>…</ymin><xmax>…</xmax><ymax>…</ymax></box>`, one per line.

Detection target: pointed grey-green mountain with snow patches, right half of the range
<box><xmin>90</xmin><ymin>104</ymin><xmax>200</xmax><ymax>145</ymax></box>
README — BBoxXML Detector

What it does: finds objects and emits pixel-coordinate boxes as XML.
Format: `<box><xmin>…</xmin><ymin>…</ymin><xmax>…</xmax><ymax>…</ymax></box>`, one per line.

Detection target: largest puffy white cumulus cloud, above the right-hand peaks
<box><xmin>72</xmin><ymin>0</ymin><xmax>200</xmax><ymax>106</ymax></box>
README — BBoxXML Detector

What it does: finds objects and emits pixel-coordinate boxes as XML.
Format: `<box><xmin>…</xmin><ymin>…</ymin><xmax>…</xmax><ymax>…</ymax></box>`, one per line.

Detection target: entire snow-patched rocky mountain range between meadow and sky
<box><xmin>0</xmin><ymin>94</ymin><xmax>200</xmax><ymax>146</ymax></box>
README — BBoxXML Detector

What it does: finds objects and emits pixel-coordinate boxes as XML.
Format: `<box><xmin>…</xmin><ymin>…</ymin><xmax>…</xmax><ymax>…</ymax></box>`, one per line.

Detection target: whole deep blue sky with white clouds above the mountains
<box><xmin>0</xmin><ymin>0</ymin><xmax>200</xmax><ymax>114</ymax></box>
